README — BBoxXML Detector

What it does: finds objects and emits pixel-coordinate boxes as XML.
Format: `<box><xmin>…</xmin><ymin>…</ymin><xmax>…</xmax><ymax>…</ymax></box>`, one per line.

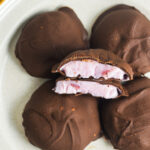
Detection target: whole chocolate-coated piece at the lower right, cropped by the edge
<box><xmin>101</xmin><ymin>77</ymin><xmax>150</xmax><ymax>150</ymax></box>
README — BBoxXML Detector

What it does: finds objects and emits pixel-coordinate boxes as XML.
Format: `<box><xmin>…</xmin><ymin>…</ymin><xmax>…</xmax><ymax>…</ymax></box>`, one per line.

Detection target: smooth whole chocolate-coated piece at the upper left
<box><xmin>16</xmin><ymin>7</ymin><xmax>89</xmax><ymax>78</ymax></box>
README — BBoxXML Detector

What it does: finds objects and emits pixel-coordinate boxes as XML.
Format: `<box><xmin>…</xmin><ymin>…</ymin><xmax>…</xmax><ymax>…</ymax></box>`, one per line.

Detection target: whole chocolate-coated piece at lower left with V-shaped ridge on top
<box><xmin>23</xmin><ymin>81</ymin><xmax>101</xmax><ymax>150</ymax></box>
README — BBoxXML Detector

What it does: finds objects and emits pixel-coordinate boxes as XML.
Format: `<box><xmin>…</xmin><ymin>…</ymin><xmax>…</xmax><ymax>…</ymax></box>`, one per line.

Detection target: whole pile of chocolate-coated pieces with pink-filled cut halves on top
<box><xmin>16</xmin><ymin>5</ymin><xmax>150</xmax><ymax>150</ymax></box>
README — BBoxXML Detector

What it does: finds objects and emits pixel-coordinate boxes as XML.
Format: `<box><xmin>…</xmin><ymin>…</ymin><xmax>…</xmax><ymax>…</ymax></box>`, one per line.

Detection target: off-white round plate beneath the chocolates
<box><xmin>0</xmin><ymin>0</ymin><xmax>150</xmax><ymax>150</ymax></box>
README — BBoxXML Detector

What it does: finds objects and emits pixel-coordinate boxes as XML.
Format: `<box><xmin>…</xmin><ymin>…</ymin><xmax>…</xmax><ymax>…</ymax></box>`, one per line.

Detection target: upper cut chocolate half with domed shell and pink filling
<box><xmin>52</xmin><ymin>49</ymin><xmax>133</xmax><ymax>81</ymax></box>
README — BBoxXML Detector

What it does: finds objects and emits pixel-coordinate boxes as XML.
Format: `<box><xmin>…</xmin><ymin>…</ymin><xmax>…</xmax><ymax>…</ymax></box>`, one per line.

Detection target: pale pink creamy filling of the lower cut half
<box><xmin>54</xmin><ymin>80</ymin><xmax>121</xmax><ymax>99</ymax></box>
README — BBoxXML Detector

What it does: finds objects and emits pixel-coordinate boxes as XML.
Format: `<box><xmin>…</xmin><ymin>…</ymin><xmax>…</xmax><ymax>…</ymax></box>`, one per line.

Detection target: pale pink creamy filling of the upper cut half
<box><xmin>60</xmin><ymin>59</ymin><xmax>129</xmax><ymax>81</ymax></box>
